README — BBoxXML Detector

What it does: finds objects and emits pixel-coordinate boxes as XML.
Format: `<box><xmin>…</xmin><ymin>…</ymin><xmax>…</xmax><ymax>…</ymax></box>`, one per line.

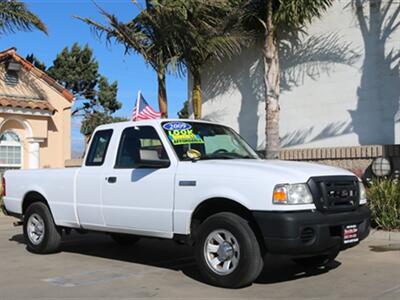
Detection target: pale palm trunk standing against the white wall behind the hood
<box><xmin>263</xmin><ymin>1</ymin><xmax>280</xmax><ymax>159</ymax></box>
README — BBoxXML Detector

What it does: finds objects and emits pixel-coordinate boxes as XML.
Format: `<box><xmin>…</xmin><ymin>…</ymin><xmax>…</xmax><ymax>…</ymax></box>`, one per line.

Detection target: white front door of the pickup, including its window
<box><xmin>102</xmin><ymin>126</ymin><xmax>175</xmax><ymax>237</ymax></box>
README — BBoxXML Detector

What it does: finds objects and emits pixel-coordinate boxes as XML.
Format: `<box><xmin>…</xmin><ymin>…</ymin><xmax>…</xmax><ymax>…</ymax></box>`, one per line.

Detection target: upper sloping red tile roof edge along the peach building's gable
<box><xmin>0</xmin><ymin>48</ymin><xmax>74</xmax><ymax>102</ymax></box>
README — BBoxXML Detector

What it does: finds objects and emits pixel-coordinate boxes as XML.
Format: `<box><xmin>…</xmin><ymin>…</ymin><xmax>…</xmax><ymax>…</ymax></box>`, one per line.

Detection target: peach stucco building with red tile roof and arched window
<box><xmin>0</xmin><ymin>48</ymin><xmax>73</xmax><ymax>171</ymax></box>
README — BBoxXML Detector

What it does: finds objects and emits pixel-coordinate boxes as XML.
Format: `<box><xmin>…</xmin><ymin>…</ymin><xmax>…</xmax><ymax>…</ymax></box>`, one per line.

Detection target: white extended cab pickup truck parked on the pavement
<box><xmin>3</xmin><ymin>120</ymin><xmax>370</xmax><ymax>287</ymax></box>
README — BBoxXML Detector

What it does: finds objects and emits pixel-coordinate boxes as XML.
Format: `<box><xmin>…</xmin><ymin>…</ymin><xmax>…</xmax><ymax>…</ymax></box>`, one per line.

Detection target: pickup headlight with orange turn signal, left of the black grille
<box><xmin>272</xmin><ymin>183</ymin><xmax>313</xmax><ymax>204</ymax></box>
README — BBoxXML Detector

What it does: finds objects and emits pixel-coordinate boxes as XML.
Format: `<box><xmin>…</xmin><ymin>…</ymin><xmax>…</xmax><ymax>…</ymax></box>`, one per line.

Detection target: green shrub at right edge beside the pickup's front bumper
<box><xmin>367</xmin><ymin>179</ymin><xmax>400</xmax><ymax>230</ymax></box>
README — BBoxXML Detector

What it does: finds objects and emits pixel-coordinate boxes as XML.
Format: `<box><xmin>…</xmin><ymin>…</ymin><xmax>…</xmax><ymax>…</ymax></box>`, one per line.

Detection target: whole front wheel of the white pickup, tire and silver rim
<box><xmin>195</xmin><ymin>212</ymin><xmax>263</xmax><ymax>288</ymax></box>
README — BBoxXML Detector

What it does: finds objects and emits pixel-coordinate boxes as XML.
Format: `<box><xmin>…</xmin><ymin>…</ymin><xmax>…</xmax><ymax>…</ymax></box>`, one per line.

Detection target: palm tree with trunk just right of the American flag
<box><xmin>77</xmin><ymin>1</ymin><xmax>178</xmax><ymax>118</ymax></box>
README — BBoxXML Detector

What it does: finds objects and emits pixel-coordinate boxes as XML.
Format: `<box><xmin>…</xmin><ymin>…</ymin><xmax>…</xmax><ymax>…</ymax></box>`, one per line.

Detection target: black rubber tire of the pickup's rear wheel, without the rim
<box><xmin>23</xmin><ymin>202</ymin><xmax>61</xmax><ymax>254</ymax></box>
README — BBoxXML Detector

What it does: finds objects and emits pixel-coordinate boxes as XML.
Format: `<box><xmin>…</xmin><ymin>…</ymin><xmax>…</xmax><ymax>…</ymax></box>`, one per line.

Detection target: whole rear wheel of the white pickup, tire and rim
<box><xmin>23</xmin><ymin>202</ymin><xmax>61</xmax><ymax>254</ymax></box>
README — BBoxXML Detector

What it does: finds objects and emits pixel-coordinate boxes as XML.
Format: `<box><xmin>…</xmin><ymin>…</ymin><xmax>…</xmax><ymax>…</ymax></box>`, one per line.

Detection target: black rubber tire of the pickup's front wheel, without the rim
<box><xmin>195</xmin><ymin>212</ymin><xmax>264</xmax><ymax>288</ymax></box>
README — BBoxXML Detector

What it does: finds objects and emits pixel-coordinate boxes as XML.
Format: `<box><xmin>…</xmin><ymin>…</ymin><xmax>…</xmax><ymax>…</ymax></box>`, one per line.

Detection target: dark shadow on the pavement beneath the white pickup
<box><xmin>10</xmin><ymin>233</ymin><xmax>340</xmax><ymax>284</ymax></box>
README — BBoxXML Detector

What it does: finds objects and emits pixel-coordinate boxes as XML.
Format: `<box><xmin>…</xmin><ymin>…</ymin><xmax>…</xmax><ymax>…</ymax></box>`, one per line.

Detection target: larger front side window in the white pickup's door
<box><xmin>115</xmin><ymin>126</ymin><xmax>168</xmax><ymax>169</ymax></box>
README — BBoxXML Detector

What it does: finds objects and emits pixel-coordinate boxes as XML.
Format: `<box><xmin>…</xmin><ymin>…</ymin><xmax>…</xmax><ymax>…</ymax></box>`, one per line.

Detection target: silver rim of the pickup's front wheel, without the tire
<box><xmin>204</xmin><ymin>229</ymin><xmax>240</xmax><ymax>275</ymax></box>
